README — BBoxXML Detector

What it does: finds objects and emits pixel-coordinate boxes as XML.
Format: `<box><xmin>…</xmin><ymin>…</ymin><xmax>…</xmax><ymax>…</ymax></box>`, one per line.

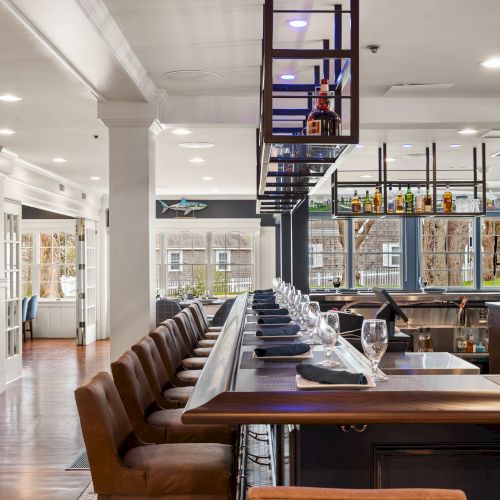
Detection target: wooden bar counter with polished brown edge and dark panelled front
<box><xmin>183</xmin><ymin>295</ymin><xmax>500</xmax><ymax>499</ymax></box>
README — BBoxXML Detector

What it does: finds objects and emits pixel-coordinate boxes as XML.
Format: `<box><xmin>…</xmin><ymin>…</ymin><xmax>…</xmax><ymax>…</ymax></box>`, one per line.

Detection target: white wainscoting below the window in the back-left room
<box><xmin>33</xmin><ymin>301</ymin><xmax>76</xmax><ymax>339</ymax></box>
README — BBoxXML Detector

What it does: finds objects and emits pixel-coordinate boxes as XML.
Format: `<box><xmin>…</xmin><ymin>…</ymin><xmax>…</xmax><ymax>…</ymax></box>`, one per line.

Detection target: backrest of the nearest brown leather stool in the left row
<box><xmin>75</xmin><ymin>372</ymin><xmax>143</xmax><ymax>493</ymax></box>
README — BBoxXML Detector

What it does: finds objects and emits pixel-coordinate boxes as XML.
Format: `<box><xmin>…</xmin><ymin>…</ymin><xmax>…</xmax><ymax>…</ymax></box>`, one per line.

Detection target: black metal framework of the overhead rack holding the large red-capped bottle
<box><xmin>257</xmin><ymin>0</ymin><xmax>359</xmax><ymax>211</ymax></box>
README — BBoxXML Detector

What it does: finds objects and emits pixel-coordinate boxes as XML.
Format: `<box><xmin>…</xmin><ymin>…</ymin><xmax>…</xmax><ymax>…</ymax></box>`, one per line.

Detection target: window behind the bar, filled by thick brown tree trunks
<box><xmin>420</xmin><ymin>217</ymin><xmax>474</xmax><ymax>287</ymax></box>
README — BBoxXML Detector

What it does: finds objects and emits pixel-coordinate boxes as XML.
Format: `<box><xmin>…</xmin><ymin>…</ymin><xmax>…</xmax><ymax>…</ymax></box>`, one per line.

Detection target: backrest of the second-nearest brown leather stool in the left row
<box><xmin>111</xmin><ymin>351</ymin><xmax>164</xmax><ymax>443</ymax></box>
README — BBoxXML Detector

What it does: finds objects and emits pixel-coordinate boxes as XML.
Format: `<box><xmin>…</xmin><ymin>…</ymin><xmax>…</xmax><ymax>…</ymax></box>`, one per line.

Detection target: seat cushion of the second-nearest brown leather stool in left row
<box><xmin>147</xmin><ymin>408</ymin><xmax>233</xmax><ymax>444</ymax></box>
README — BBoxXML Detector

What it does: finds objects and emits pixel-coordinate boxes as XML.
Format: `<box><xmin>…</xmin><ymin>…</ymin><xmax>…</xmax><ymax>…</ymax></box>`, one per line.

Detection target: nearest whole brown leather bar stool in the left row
<box><xmin>75</xmin><ymin>372</ymin><xmax>234</xmax><ymax>500</ymax></box>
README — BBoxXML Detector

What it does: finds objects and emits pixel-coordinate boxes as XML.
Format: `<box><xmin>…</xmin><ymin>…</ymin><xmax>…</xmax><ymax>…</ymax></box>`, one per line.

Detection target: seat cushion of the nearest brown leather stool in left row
<box><xmin>123</xmin><ymin>443</ymin><xmax>231</xmax><ymax>498</ymax></box>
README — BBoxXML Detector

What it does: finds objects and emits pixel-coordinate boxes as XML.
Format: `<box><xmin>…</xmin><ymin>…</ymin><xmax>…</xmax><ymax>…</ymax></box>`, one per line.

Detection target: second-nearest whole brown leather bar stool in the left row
<box><xmin>111</xmin><ymin>351</ymin><xmax>234</xmax><ymax>444</ymax></box>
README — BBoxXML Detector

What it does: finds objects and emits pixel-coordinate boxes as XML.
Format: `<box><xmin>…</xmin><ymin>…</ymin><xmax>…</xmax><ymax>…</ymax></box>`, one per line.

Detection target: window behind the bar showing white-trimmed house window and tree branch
<box><xmin>352</xmin><ymin>219</ymin><xmax>401</xmax><ymax>288</ymax></box>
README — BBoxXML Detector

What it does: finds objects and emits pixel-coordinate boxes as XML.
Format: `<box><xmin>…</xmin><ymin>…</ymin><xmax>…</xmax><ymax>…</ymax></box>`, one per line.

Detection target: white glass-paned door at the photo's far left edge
<box><xmin>1</xmin><ymin>202</ymin><xmax>23</xmax><ymax>383</ymax></box>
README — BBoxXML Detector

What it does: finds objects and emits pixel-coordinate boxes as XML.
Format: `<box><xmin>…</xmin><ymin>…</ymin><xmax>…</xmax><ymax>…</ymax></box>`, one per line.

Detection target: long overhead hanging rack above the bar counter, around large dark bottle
<box><xmin>257</xmin><ymin>0</ymin><xmax>359</xmax><ymax>212</ymax></box>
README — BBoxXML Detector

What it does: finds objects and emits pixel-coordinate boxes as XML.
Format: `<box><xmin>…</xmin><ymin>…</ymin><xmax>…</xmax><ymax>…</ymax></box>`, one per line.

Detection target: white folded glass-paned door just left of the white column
<box><xmin>76</xmin><ymin>219</ymin><xmax>97</xmax><ymax>345</ymax></box>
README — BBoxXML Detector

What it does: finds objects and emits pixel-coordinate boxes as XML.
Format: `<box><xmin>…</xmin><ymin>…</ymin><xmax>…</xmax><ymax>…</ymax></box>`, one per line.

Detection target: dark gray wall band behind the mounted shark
<box><xmin>156</xmin><ymin>198</ymin><xmax>274</xmax><ymax>226</ymax></box>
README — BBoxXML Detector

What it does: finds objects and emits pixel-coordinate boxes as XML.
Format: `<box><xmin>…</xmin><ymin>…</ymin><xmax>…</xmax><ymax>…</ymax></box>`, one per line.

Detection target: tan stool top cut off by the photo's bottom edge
<box><xmin>247</xmin><ymin>486</ymin><xmax>467</xmax><ymax>500</ymax></box>
